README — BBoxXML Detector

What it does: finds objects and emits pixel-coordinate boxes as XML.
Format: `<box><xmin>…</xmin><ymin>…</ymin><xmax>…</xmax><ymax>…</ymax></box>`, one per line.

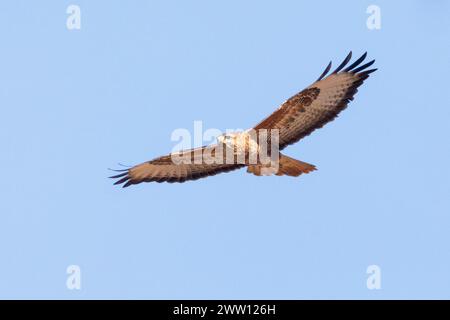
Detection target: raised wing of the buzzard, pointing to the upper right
<box><xmin>254</xmin><ymin>52</ymin><xmax>377</xmax><ymax>150</ymax></box>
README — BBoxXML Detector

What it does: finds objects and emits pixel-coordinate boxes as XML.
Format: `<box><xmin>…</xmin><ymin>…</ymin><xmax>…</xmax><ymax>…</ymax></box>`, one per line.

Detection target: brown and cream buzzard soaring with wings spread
<box><xmin>111</xmin><ymin>52</ymin><xmax>377</xmax><ymax>187</ymax></box>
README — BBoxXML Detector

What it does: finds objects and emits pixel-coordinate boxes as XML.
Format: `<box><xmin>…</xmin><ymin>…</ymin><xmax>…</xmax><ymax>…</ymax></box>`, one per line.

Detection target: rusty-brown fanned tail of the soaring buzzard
<box><xmin>247</xmin><ymin>153</ymin><xmax>316</xmax><ymax>177</ymax></box>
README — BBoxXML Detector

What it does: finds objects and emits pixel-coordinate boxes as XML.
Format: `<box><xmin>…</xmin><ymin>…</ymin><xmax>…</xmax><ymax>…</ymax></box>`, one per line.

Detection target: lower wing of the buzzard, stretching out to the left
<box><xmin>110</xmin><ymin>145</ymin><xmax>244</xmax><ymax>188</ymax></box>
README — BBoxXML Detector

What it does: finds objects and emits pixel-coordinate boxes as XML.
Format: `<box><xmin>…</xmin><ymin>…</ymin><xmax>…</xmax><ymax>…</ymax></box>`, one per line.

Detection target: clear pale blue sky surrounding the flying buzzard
<box><xmin>0</xmin><ymin>0</ymin><xmax>450</xmax><ymax>299</ymax></box>
